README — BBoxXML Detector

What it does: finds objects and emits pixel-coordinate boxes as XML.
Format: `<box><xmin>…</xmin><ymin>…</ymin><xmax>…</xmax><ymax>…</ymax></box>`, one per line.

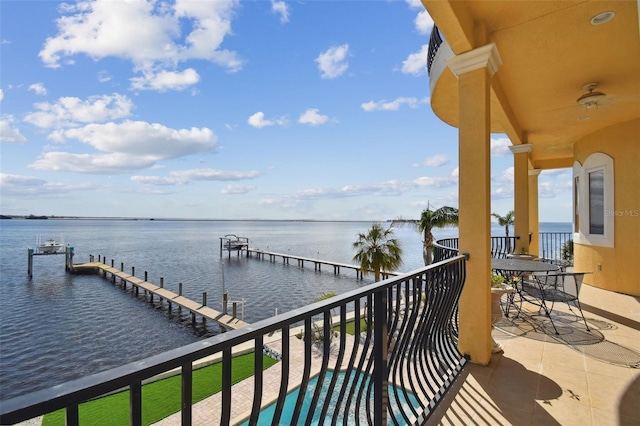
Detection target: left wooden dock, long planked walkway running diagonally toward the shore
<box><xmin>72</xmin><ymin>262</ymin><xmax>249</xmax><ymax>330</ymax></box>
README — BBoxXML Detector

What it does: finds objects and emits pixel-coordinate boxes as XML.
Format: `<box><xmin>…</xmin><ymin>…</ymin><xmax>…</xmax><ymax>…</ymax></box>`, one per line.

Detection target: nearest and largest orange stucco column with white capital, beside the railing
<box><xmin>447</xmin><ymin>44</ymin><xmax>502</xmax><ymax>365</ymax></box>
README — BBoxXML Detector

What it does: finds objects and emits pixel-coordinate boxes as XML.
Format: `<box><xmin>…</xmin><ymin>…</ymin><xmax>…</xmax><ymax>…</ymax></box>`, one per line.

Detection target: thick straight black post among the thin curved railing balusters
<box><xmin>373</xmin><ymin>290</ymin><xmax>389</xmax><ymax>426</ymax></box>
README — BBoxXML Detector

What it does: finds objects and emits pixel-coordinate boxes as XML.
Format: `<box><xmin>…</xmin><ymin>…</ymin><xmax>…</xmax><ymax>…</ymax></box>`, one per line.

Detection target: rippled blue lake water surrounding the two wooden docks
<box><xmin>0</xmin><ymin>219</ymin><xmax>571</xmax><ymax>399</ymax></box>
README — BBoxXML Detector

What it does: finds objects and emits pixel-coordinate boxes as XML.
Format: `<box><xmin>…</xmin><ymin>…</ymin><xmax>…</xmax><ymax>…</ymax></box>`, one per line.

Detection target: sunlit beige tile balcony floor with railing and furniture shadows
<box><xmin>427</xmin><ymin>285</ymin><xmax>640</xmax><ymax>426</ymax></box>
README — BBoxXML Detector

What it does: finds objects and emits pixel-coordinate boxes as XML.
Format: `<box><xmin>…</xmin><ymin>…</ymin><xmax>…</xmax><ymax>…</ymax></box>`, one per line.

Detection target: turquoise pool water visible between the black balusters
<box><xmin>242</xmin><ymin>371</ymin><xmax>419</xmax><ymax>426</ymax></box>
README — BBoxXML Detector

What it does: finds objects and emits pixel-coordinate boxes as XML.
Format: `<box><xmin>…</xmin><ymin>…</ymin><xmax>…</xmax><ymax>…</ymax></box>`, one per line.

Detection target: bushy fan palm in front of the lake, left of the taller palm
<box><xmin>353</xmin><ymin>222</ymin><xmax>402</xmax><ymax>282</ymax></box>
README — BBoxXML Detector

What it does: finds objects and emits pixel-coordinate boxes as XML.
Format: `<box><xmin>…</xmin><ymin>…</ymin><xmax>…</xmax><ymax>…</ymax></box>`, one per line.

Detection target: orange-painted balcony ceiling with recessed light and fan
<box><xmin>423</xmin><ymin>0</ymin><xmax>640</xmax><ymax>169</ymax></box>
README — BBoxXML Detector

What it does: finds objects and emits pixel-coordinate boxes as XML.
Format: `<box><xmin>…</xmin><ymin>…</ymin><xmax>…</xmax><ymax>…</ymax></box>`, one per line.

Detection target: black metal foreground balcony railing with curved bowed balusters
<box><xmin>0</xmin><ymin>256</ymin><xmax>466</xmax><ymax>425</ymax></box>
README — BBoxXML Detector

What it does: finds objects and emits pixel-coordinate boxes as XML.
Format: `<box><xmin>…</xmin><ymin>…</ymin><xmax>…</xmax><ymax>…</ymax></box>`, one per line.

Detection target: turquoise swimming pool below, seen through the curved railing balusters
<box><xmin>241</xmin><ymin>370</ymin><xmax>418</xmax><ymax>426</ymax></box>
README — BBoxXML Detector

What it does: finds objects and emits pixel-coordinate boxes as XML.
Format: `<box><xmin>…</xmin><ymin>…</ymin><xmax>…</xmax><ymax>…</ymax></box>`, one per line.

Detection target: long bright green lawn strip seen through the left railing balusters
<box><xmin>42</xmin><ymin>354</ymin><xmax>276</xmax><ymax>426</ymax></box>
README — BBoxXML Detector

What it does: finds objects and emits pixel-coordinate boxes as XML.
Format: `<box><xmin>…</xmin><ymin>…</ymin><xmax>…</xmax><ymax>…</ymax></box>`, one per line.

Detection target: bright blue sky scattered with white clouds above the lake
<box><xmin>0</xmin><ymin>0</ymin><xmax>571</xmax><ymax>222</ymax></box>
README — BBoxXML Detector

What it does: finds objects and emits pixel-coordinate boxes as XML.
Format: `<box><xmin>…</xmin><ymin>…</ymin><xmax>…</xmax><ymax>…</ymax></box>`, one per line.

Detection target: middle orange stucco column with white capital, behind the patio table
<box><xmin>509</xmin><ymin>144</ymin><xmax>533</xmax><ymax>253</ymax></box>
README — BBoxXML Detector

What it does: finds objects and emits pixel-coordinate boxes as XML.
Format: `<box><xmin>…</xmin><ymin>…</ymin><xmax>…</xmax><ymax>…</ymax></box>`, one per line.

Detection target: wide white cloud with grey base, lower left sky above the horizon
<box><xmin>50</xmin><ymin>120</ymin><xmax>217</xmax><ymax>161</ymax></box>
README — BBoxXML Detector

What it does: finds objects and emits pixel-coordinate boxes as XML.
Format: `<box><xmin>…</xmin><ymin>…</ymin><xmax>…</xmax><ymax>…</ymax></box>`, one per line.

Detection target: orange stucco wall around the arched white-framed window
<box><xmin>574</xmin><ymin>119</ymin><xmax>640</xmax><ymax>296</ymax></box>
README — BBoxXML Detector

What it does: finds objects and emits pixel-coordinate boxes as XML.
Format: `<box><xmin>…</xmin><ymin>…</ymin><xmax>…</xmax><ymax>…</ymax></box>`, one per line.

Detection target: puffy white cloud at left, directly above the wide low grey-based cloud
<box><xmin>25</xmin><ymin>93</ymin><xmax>133</xmax><ymax>128</ymax></box>
